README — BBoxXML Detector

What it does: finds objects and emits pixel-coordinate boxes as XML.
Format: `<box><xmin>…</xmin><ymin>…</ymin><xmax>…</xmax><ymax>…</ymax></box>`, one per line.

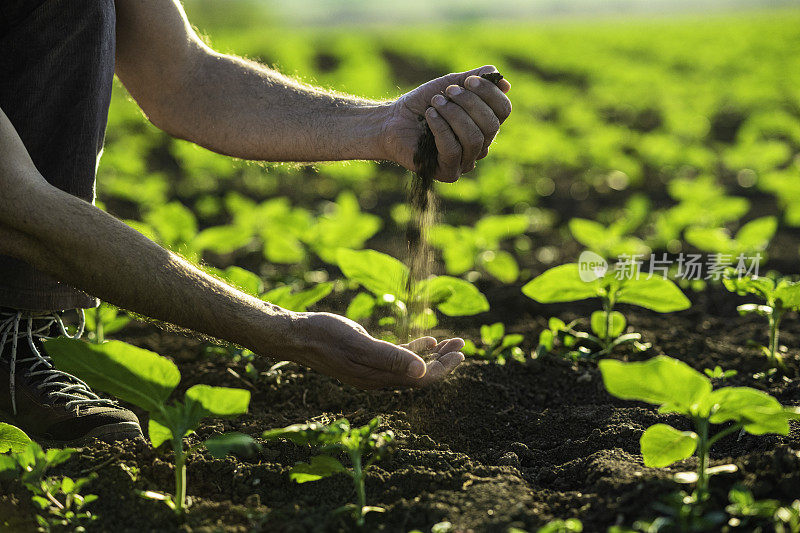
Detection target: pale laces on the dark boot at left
<box><xmin>0</xmin><ymin>310</ymin><xmax>116</xmax><ymax>415</ymax></box>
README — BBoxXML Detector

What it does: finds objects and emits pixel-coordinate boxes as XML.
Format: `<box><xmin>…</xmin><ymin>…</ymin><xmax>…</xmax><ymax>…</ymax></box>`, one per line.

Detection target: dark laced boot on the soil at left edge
<box><xmin>0</xmin><ymin>308</ymin><xmax>142</xmax><ymax>447</ymax></box>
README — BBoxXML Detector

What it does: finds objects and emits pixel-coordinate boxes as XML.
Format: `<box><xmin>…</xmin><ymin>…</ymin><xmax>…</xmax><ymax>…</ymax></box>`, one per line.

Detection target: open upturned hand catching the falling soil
<box><xmin>286</xmin><ymin>313</ymin><xmax>464</xmax><ymax>389</ymax></box>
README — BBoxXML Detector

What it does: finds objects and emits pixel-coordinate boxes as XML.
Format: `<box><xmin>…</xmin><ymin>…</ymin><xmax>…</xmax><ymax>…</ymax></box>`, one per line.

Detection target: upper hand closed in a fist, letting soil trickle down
<box><xmin>383</xmin><ymin>65</ymin><xmax>511</xmax><ymax>182</ymax></box>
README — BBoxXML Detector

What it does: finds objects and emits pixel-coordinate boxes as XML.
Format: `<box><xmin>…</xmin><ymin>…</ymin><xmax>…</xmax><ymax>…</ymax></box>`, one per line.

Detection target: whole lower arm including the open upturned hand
<box><xmin>0</xmin><ymin>110</ymin><xmax>463</xmax><ymax>388</ymax></box>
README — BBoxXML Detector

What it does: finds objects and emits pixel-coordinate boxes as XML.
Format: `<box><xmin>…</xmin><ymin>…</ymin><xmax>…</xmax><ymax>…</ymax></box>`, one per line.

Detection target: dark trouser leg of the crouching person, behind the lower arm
<box><xmin>0</xmin><ymin>0</ymin><xmax>116</xmax><ymax>310</ymax></box>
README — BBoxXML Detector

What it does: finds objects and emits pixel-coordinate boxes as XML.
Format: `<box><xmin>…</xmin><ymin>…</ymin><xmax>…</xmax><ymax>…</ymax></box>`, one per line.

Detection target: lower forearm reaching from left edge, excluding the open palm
<box><xmin>0</xmin><ymin>168</ymin><xmax>299</xmax><ymax>356</ymax></box>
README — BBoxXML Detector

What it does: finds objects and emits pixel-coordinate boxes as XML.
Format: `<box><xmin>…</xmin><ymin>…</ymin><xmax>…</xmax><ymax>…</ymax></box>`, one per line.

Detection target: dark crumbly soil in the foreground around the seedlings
<box><xmin>0</xmin><ymin>280</ymin><xmax>800</xmax><ymax>533</ymax></box>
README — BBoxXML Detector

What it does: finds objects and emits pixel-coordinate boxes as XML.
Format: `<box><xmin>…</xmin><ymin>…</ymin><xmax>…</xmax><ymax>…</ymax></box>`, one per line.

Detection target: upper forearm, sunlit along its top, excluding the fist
<box><xmin>122</xmin><ymin>47</ymin><xmax>388</xmax><ymax>161</ymax></box>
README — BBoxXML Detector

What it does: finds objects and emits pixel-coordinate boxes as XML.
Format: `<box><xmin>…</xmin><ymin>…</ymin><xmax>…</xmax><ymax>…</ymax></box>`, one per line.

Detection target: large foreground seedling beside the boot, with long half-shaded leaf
<box><xmin>45</xmin><ymin>338</ymin><xmax>254</xmax><ymax>514</ymax></box>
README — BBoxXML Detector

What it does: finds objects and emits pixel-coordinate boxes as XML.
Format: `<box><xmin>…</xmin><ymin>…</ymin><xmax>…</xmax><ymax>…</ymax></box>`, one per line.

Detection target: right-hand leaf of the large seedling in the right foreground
<box><xmin>704</xmin><ymin>387</ymin><xmax>789</xmax><ymax>435</ymax></box>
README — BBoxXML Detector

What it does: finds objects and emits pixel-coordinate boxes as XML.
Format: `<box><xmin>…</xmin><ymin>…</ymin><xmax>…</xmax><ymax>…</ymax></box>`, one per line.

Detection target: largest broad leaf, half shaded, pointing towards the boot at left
<box><xmin>44</xmin><ymin>338</ymin><xmax>181</xmax><ymax>413</ymax></box>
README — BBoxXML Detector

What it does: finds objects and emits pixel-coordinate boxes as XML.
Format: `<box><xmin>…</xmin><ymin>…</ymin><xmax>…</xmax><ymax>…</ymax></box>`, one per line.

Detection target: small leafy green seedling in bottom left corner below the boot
<box><xmin>0</xmin><ymin>424</ymin><xmax>97</xmax><ymax>532</ymax></box>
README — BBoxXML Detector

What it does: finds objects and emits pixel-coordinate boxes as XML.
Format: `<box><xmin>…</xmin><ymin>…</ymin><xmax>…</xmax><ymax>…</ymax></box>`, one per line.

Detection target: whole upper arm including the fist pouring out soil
<box><xmin>117</xmin><ymin>0</ymin><xmax>511</xmax><ymax>181</ymax></box>
